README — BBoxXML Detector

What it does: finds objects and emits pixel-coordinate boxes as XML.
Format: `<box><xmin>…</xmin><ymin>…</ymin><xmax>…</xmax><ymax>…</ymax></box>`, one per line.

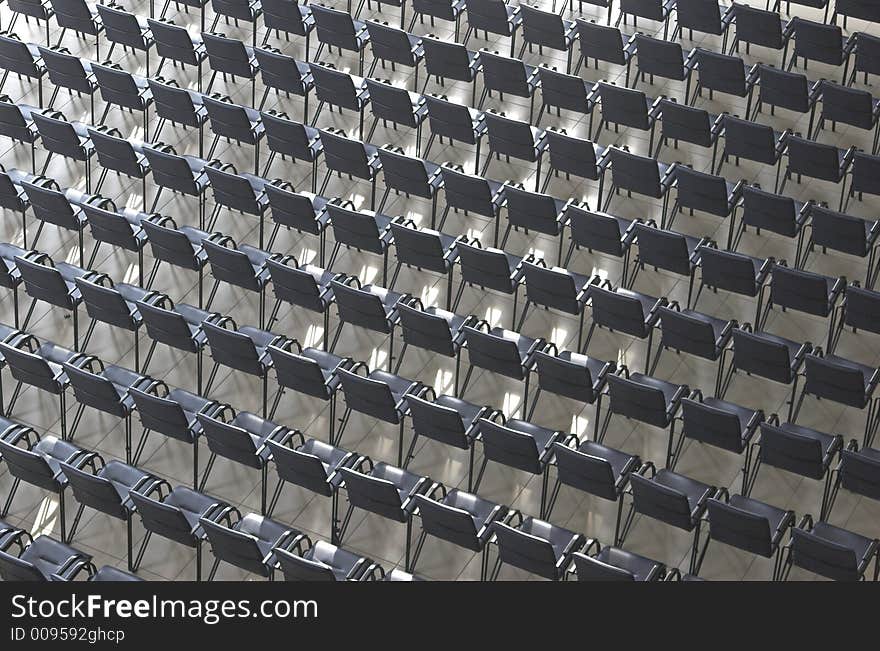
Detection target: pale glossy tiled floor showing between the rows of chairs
<box><xmin>0</xmin><ymin>0</ymin><xmax>880</xmax><ymax>580</ymax></box>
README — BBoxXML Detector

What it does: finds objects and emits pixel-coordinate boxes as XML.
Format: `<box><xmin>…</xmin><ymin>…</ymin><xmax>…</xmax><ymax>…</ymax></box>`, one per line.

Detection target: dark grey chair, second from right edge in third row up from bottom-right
<box><xmin>717</xmin><ymin>324</ymin><xmax>813</xmax><ymax>420</ymax></box>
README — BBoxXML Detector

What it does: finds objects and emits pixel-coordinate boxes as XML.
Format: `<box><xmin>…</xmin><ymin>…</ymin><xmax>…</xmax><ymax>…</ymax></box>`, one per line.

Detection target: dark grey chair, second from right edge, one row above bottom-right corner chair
<box><xmin>744</xmin><ymin>414</ymin><xmax>843</xmax><ymax>518</ymax></box>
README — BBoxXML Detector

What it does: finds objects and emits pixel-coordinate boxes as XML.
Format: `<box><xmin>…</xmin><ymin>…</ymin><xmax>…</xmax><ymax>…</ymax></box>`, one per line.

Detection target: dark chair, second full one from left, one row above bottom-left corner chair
<box><xmin>60</xmin><ymin>455</ymin><xmax>164</xmax><ymax>570</ymax></box>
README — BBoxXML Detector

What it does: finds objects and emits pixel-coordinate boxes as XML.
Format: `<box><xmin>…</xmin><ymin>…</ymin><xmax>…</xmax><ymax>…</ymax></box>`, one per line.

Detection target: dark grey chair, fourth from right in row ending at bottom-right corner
<box><xmin>546</xmin><ymin>438</ymin><xmax>642</xmax><ymax>545</ymax></box>
